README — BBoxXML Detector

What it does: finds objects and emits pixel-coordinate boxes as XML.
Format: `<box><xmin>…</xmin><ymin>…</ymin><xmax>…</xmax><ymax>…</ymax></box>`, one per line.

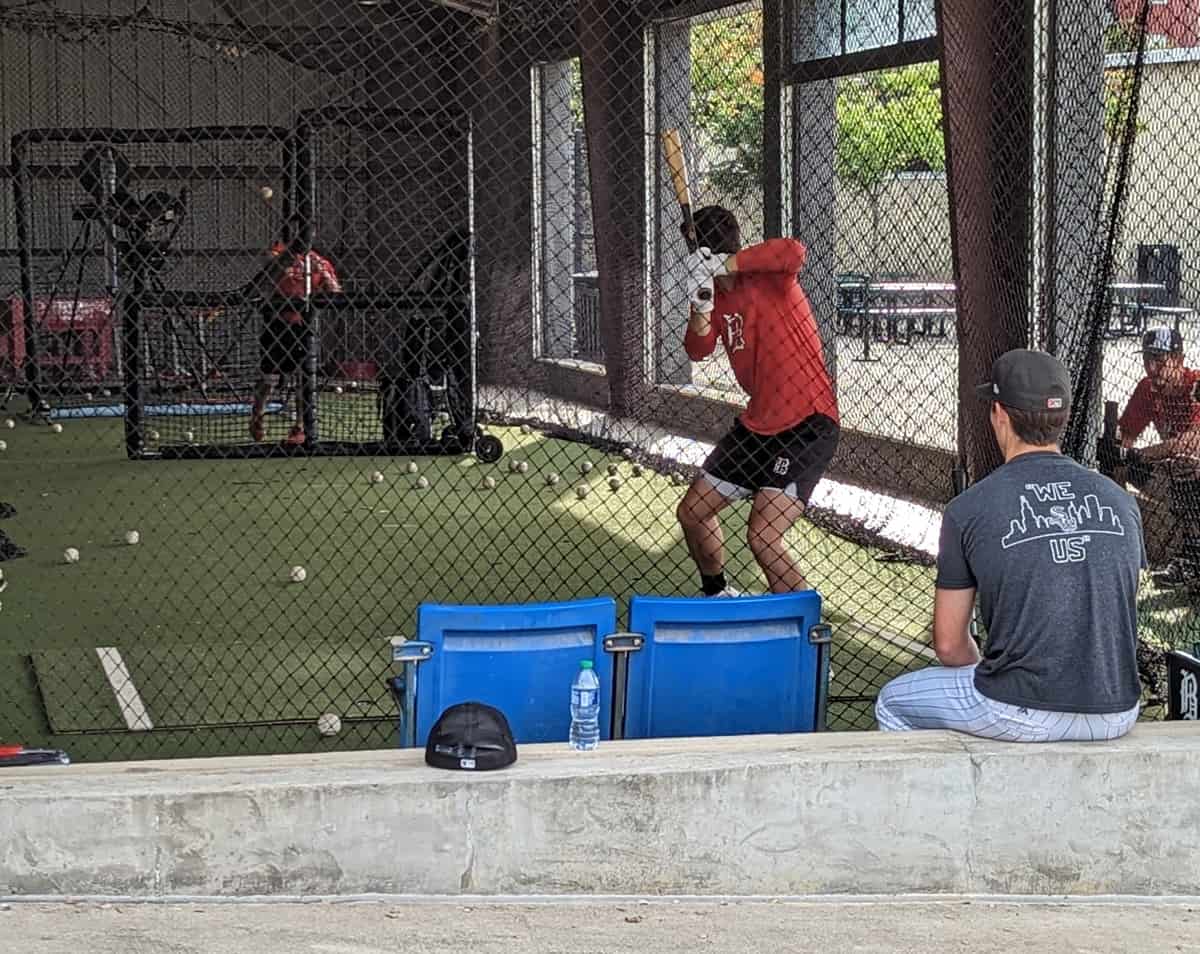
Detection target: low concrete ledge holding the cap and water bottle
<box><xmin>0</xmin><ymin>724</ymin><xmax>1200</xmax><ymax>898</ymax></box>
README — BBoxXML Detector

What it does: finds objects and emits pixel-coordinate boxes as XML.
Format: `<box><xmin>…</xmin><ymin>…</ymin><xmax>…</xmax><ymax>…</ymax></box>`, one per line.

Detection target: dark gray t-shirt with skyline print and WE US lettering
<box><xmin>937</xmin><ymin>451</ymin><xmax>1146</xmax><ymax>713</ymax></box>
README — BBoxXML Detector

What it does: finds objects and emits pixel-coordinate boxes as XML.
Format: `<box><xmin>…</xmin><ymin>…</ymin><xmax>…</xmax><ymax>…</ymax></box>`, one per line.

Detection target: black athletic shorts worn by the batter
<box><xmin>704</xmin><ymin>414</ymin><xmax>841</xmax><ymax>504</ymax></box>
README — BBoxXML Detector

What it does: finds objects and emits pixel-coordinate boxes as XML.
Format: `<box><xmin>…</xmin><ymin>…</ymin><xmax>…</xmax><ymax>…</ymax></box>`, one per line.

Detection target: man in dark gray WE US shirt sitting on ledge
<box><xmin>875</xmin><ymin>350</ymin><xmax>1146</xmax><ymax>742</ymax></box>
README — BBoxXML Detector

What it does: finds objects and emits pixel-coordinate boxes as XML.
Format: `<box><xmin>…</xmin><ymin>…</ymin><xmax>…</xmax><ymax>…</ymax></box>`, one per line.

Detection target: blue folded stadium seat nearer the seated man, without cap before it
<box><xmin>617</xmin><ymin>590</ymin><xmax>829</xmax><ymax>739</ymax></box>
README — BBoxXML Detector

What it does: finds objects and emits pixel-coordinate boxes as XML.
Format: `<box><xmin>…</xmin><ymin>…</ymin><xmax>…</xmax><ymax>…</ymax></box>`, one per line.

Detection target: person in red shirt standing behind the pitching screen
<box><xmin>250</xmin><ymin>216</ymin><xmax>342</xmax><ymax>444</ymax></box>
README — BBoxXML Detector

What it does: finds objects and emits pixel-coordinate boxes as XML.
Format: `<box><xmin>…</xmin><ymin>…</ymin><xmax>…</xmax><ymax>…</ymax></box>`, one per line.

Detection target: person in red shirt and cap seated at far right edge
<box><xmin>1117</xmin><ymin>328</ymin><xmax>1200</xmax><ymax>589</ymax></box>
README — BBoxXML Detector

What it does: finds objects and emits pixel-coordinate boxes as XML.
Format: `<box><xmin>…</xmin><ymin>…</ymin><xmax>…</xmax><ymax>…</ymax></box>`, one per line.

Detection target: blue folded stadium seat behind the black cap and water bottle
<box><xmin>391</xmin><ymin>598</ymin><xmax>617</xmax><ymax>746</ymax></box>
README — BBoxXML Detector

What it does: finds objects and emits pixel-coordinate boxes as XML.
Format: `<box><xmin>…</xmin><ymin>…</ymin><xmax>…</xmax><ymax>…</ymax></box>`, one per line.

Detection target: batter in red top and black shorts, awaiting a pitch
<box><xmin>676</xmin><ymin>205</ymin><xmax>839</xmax><ymax>596</ymax></box>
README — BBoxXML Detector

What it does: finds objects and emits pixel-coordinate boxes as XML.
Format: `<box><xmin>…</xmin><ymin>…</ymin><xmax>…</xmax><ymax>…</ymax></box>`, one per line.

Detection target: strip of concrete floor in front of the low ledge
<box><xmin>0</xmin><ymin>900</ymin><xmax>1200</xmax><ymax>954</ymax></box>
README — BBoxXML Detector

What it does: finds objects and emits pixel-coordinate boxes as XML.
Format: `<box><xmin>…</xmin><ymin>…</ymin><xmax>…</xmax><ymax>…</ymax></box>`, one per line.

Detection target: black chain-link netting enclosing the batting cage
<box><xmin>0</xmin><ymin>0</ymin><xmax>1200</xmax><ymax>758</ymax></box>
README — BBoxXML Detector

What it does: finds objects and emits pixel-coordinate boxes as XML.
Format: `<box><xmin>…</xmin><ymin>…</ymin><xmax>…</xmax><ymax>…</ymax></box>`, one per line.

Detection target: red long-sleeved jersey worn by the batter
<box><xmin>683</xmin><ymin>239</ymin><xmax>838</xmax><ymax>434</ymax></box>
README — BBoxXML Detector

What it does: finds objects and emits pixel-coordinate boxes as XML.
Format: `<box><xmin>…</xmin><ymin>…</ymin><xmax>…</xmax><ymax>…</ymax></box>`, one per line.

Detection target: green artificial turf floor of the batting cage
<box><xmin>0</xmin><ymin>410</ymin><xmax>931</xmax><ymax>758</ymax></box>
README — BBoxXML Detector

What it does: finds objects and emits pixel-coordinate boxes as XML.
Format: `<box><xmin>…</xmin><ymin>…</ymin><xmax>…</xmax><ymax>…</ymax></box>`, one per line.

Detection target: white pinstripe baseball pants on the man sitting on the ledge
<box><xmin>875</xmin><ymin>666</ymin><xmax>1139</xmax><ymax>742</ymax></box>
